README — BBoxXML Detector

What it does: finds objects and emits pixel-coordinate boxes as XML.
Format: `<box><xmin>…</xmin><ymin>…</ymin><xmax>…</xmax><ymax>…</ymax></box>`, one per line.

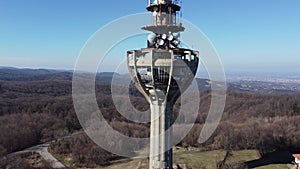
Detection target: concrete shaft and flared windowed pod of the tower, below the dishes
<box><xmin>127</xmin><ymin>48</ymin><xmax>199</xmax><ymax>169</ymax></box>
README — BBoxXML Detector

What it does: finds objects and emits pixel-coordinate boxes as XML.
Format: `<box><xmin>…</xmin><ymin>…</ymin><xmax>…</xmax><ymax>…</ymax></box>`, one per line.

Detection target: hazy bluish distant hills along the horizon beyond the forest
<box><xmin>0</xmin><ymin>67</ymin><xmax>300</xmax><ymax>93</ymax></box>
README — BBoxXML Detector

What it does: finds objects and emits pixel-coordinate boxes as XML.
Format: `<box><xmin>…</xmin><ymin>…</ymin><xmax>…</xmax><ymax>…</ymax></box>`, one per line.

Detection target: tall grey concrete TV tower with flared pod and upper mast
<box><xmin>127</xmin><ymin>0</ymin><xmax>199</xmax><ymax>169</ymax></box>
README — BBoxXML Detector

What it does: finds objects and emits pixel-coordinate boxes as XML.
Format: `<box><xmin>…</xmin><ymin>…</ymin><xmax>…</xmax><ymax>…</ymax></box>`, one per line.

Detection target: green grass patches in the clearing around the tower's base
<box><xmin>51</xmin><ymin>148</ymin><xmax>291</xmax><ymax>169</ymax></box>
